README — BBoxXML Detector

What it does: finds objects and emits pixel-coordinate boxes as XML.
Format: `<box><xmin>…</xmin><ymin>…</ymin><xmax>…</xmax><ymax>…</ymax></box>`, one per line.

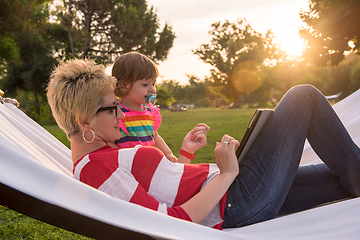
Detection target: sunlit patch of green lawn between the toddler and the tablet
<box><xmin>158</xmin><ymin>108</ymin><xmax>255</xmax><ymax>163</ymax></box>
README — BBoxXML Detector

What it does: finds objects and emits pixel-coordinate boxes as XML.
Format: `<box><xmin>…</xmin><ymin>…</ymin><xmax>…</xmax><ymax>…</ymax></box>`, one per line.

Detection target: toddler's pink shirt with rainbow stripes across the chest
<box><xmin>115</xmin><ymin>103</ymin><xmax>161</xmax><ymax>148</ymax></box>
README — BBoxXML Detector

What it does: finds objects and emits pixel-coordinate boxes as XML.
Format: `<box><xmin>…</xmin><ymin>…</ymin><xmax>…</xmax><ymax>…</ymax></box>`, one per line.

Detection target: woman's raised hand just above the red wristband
<box><xmin>181</xmin><ymin>123</ymin><xmax>210</xmax><ymax>153</ymax></box>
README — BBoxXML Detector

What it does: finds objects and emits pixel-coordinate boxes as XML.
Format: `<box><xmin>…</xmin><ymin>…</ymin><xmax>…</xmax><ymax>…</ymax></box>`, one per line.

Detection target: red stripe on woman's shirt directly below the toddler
<box><xmin>131</xmin><ymin>146</ymin><xmax>164</xmax><ymax>192</ymax></box>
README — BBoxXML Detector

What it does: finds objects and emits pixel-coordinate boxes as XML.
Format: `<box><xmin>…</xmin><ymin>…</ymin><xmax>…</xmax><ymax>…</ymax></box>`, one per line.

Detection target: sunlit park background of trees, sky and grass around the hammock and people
<box><xmin>0</xmin><ymin>0</ymin><xmax>360</xmax><ymax>239</ymax></box>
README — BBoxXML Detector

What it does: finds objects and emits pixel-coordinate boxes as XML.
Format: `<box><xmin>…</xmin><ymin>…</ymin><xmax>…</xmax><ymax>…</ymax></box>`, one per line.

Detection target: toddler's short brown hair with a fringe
<box><xmin>111</xmin><ymin>52</ymin><xmax>159</xmax><ymax>98</ymax></box>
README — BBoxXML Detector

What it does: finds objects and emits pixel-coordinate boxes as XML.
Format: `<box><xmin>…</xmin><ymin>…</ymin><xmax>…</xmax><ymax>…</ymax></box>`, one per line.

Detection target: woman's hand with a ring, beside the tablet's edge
<box><xmin>214</xmin><ymin>134</ymin><xmax>240</xmax><ymax>176</ymax></box>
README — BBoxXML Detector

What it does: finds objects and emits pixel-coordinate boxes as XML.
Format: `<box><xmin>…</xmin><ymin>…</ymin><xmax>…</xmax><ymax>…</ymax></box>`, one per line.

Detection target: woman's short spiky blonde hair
<box><xmin>47</xmin><ymin>59</ymin><xmax>116</xmax><ymax>137</ymax></box>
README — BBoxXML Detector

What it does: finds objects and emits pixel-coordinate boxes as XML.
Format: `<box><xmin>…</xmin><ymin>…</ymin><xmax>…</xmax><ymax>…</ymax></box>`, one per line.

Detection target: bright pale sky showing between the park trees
<box><xmin>109</xmin><ymin>0</ymin><xmax>308</xmax><ymax>84</ymax></box>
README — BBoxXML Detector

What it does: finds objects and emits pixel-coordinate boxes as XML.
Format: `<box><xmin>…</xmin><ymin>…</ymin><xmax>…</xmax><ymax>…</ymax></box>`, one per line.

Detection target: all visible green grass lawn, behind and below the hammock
<box><xmin>0</xmin><ymin>108</ymin><xmax>255</xmax><ymax>239</ymax></box>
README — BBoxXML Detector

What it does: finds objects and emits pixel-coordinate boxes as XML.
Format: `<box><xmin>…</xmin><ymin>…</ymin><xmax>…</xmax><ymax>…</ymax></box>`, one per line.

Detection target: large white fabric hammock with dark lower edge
<box><xmin>0</xmin><ymin>90</ymin><xmax>360</xmax><ymax>240</ymax></box>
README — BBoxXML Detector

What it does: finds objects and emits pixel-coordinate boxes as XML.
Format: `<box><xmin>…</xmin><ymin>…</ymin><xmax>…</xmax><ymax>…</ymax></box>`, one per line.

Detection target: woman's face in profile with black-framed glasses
<box><xmin>90</xmin><ymin>92</ymin><xmax>125</xmax><ymax>143</ymax></box>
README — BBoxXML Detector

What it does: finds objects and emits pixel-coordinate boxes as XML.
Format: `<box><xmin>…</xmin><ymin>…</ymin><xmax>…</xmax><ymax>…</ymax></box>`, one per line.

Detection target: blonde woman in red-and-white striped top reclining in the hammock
<box><xmin>47</xmin><ymin>60</ymin><xmax>360</xmax><ymax>229</ymax></box>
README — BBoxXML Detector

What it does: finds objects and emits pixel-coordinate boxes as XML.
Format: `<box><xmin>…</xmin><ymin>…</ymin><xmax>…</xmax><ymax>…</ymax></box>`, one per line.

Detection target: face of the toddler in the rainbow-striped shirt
<box><xmin>123</xmin><ymin>78</ymin><xmax>156</xmax><ymax>104</ymax></box>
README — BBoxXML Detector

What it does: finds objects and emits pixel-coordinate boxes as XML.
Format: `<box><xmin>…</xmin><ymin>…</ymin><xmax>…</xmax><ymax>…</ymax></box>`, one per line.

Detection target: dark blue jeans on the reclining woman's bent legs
<box><xmin>223</xmin><ymin>85</ymin><xmax>360</xmax><ymax>228</ymax></box>
